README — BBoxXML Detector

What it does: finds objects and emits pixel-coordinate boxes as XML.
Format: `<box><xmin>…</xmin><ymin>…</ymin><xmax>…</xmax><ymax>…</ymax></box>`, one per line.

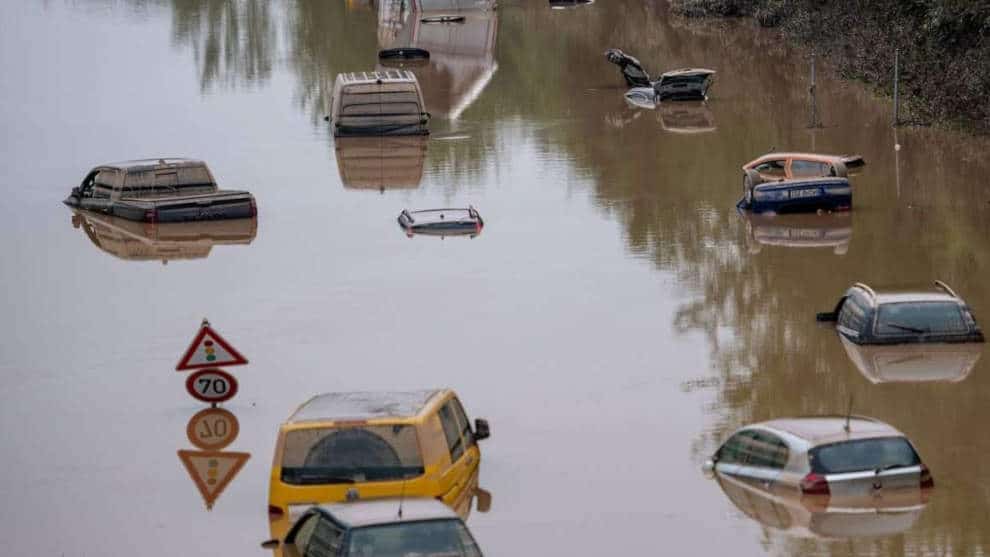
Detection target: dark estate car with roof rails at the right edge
<box><xmin>816</xmin><ymin>280</ymin><xmax>983</xmax><ymax>344</ymax></box>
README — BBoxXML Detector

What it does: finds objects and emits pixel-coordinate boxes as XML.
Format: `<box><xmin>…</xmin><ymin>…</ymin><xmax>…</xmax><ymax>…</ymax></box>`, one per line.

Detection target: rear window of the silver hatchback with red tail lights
<box><xmin>810</xmin><ymin>437</ymin><xmax>921</xmax><ymax>474</ymax></box>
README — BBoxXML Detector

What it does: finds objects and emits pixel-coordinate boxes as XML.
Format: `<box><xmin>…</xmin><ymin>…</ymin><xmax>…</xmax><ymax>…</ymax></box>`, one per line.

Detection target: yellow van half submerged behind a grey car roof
<box><xmin>268</xmin><ymin>389</ymin><xmax>490</xmax><ymax>539</ymax></box>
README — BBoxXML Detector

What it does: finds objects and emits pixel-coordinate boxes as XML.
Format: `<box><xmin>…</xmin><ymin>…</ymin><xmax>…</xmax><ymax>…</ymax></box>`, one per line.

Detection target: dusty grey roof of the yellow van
<box><xmin>288</xmin><ymin>389</ymin><xmax>443</xmax><ymax>423</ymax></box>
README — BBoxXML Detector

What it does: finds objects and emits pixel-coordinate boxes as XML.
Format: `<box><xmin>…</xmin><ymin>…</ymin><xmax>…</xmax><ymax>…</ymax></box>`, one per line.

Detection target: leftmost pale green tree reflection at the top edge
<box><xmin>170</xmin><ymin>0</ymin><xmax>277</xmax><ymax>91</ymax></box>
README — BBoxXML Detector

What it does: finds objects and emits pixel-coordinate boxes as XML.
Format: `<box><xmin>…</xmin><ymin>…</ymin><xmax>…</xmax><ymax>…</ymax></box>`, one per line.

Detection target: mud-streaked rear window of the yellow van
<box><xmin>282</xmin><ymin>424</ymin><xmax>423</xmax><ymax>485</ymax></box>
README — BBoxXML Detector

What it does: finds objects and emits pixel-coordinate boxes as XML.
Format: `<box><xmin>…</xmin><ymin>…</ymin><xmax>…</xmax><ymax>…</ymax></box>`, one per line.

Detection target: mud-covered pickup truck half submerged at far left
<box><xmin>64</xmin><ymin>158</ymin><xmax>258</xmax><ymax>222</ymax></box>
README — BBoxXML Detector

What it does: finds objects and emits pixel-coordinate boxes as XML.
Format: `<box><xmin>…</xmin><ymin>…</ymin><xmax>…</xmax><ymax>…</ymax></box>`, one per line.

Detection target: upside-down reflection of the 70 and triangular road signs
<box><xmin>177</xmin><ymin>407</ymin><xmax>251</xmax><ymax>510</ymax></box>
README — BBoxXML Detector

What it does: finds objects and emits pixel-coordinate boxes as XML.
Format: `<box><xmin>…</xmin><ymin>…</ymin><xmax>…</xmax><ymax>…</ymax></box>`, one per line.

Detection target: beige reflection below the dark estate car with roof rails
<box><xmin>837</xmin><ymin>335</ymin><xmax>983</xmax><ymax>383</ymax></box>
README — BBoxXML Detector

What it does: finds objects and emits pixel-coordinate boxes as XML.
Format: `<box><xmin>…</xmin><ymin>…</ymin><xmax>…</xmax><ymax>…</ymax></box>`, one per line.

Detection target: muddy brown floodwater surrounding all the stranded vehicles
<box><xmin>0</xmin><ymin>0</ymin><xmax>990</xmax><ymax>556</ymax></box>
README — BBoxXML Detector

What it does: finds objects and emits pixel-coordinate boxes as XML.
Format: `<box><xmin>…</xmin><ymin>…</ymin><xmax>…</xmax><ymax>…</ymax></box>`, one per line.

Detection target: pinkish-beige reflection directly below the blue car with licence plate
<box><xmin>739</xmin><ymin>211</ymin><xmax>852</xmax><ymax>255</ymax></box>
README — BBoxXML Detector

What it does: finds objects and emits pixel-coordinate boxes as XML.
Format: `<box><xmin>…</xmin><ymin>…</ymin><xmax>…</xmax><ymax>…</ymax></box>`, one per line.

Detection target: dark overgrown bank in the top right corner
<box><xmin>671</xmin><ymin>0</ymin><xmax>990</xmax><ymax>133</ymax></box>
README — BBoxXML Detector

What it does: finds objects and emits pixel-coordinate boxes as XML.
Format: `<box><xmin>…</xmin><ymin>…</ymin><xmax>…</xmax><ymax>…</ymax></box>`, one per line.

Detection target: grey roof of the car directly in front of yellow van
<box><xmin>319</xmin><ymin>497</ymin><xmax>458</xmax><ymax>528</ymax></box>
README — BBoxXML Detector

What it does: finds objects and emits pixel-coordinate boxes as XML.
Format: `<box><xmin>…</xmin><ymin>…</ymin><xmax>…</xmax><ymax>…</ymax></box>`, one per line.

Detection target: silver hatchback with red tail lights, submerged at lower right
<box><xmin>705</xmin><ymin>416</ymin><xmax>935</xmax><ymax>510</ymax></box>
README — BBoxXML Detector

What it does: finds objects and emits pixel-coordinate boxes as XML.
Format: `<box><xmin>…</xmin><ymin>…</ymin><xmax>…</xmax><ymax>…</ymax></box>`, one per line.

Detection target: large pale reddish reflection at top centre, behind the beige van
<box><xmin>378</xmin><ymin>2</ymin><xmax>498</xmax><ymax>120</ymax></box>
